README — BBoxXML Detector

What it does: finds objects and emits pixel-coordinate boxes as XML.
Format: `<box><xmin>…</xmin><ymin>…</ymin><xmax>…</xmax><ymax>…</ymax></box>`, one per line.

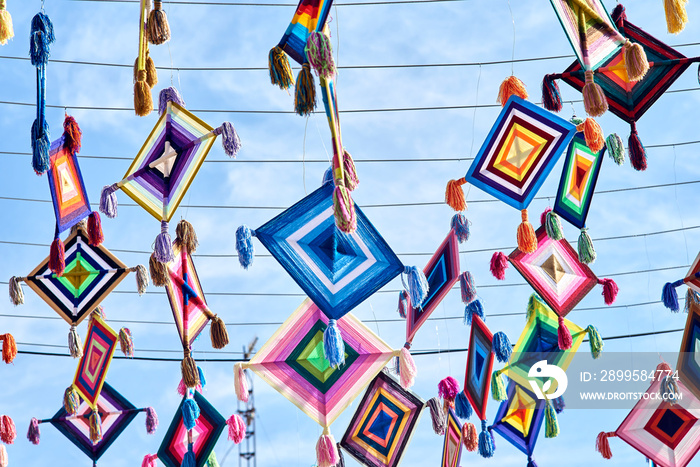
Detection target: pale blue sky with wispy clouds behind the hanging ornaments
<box><xmin>0</xmin><ymin>0</ymin><xmax>700</xmax><ymax>467</ymax></box>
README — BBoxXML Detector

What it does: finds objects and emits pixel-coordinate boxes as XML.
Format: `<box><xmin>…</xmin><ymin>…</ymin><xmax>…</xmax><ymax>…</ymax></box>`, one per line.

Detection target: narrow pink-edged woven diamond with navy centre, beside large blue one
<box><xmin>406</xmin><ymin>230</ymin><xmax>460</xmax><ymax>342</ymax></box>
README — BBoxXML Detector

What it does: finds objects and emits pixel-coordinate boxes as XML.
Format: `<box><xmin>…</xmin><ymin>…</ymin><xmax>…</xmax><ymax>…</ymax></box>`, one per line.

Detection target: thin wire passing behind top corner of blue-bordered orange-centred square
<box><xmin>0</xmin><ymin>88</ymin><xmax>700</xmax><ymax>115</ymax></box>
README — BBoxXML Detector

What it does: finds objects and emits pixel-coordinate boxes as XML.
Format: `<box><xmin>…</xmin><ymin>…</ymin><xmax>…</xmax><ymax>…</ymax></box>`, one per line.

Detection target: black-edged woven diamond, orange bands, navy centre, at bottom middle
<box><xmin>340</xmin><ymin>372</ymin><xmax>424</xmax><ymax>467</ymax></box>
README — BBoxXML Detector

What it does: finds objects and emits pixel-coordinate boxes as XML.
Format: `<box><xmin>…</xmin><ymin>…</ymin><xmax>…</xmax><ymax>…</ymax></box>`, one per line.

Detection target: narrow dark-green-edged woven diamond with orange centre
<box><xmin>553</xmin><ymin>133</ymin><xmax>605</xmax><ymax>229</ymax></box>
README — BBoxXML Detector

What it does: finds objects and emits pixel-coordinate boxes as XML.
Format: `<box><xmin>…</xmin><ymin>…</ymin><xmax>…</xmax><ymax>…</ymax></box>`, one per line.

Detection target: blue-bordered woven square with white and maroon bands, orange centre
<box><xmin>464</xmin><ymin>96</ymin><xmax>576</xmax><ymax>209</ymax></box>
